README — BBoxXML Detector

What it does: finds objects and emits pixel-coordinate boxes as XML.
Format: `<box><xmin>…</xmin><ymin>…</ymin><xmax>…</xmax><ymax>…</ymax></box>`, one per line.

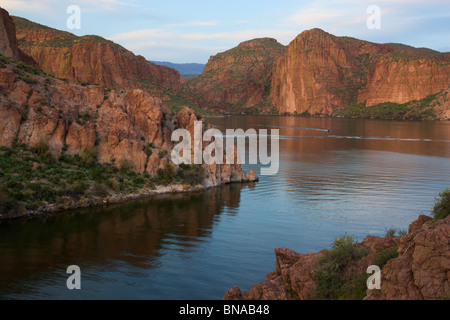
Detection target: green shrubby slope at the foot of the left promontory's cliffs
<box><xmin>0</xmin><ymin>141</ymin><xmax>205</xmax><ymax>217</ymax></box>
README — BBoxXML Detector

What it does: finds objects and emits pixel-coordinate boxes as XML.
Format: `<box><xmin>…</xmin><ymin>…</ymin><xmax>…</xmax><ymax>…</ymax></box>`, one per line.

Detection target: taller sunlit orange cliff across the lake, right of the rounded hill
<box><xmin>270</xmin><ymin>29</ymin><xmax>450</xmax><ymax>115</ymax></box>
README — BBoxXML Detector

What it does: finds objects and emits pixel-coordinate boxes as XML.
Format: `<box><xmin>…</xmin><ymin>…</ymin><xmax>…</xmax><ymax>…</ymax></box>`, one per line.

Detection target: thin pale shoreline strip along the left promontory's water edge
<box><xmin>0</xmin><ymin>178</ymin><xmax>259</xmax><ymax>223</ymax></box>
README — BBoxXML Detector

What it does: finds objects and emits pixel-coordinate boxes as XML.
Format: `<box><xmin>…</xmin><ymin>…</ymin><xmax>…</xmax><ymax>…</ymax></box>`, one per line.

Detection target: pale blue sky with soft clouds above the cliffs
<box><xmin>0</xmin><ymin>0</ymin><xmax>450</xmax><ymax>63</ymax></box>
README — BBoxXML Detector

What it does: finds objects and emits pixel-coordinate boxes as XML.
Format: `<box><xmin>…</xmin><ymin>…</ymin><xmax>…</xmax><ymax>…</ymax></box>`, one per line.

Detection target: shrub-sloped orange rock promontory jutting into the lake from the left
<box><xmin>0</xmin><ymin>6</ymin><xmax>256</xmax><ymax>218</ymax></box>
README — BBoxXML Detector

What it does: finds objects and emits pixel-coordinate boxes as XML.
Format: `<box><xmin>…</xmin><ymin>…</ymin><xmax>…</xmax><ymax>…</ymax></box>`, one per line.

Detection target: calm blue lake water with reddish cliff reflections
<box><xmin>0</xmin><ymin>116</ymin><xmax>450</xmax><ymax>299</ymax></box>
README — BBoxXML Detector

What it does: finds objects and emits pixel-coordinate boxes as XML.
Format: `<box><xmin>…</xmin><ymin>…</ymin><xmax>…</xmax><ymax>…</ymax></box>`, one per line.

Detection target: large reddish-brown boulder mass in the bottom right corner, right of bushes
<box><xmin>367</xmin><ymin>216</ymin><xmax>450</xmax><ymax>300</ymax></box>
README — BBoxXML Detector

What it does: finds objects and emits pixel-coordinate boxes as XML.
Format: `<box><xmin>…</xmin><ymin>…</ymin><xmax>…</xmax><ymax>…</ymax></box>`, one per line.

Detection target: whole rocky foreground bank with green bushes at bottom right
<box><xmin>224</xmin><ymin>216</ymin><xmax>450</xmax><ymax>300</ymax></box>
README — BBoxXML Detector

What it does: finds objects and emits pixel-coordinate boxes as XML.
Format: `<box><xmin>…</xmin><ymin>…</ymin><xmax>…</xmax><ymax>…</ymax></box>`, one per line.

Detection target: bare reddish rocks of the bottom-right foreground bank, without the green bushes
<box><xmin>224</xmin><ymin>216</ymin><xmax>450</xmax><ymax>300</ymax></box>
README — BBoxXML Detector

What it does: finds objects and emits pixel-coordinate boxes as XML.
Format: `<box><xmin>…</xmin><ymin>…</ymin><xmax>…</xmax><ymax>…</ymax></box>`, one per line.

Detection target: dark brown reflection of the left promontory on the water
<box><xmin>0</xmin><ymin>184</ymin><xmax>254</xmax><ymax>298</ymax></box>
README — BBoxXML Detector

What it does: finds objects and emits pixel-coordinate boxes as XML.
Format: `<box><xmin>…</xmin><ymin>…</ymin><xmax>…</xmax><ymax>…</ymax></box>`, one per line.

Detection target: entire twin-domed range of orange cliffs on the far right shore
<box><xmin>183</xmin><ymin>29</ymin><xmax>450</xmax><ymax>119</ymax></box>
